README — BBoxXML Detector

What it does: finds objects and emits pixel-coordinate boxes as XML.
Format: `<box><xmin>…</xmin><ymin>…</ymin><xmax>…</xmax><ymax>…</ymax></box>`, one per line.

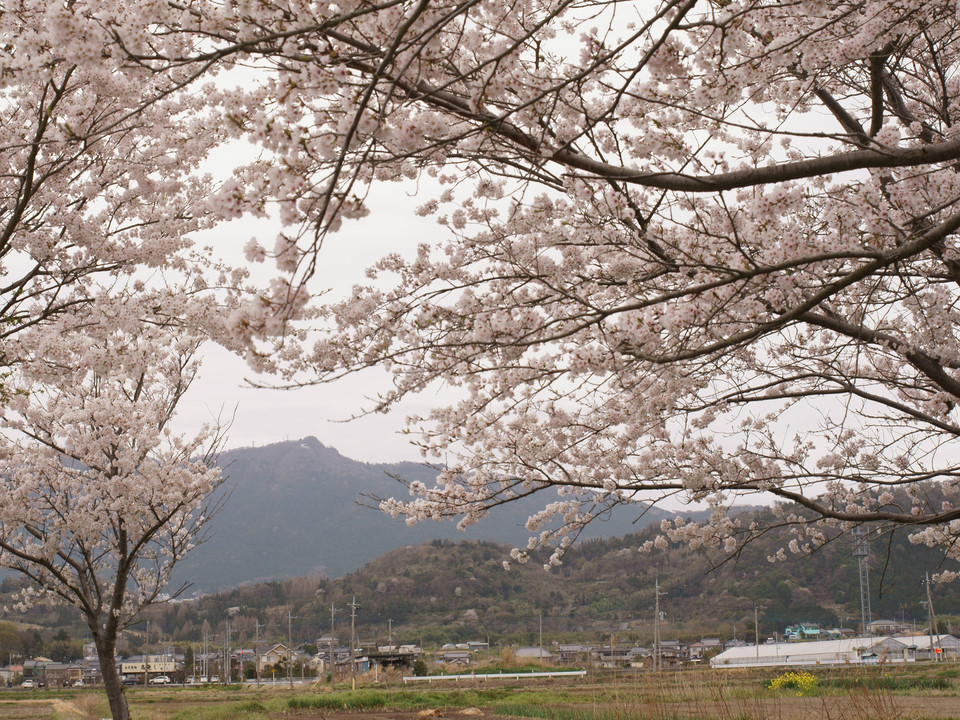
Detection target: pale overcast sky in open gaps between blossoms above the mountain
<box><xmin>178</xmin><ymin>179</ymin><xmax>443</xmax><ymax>462</ymax></box>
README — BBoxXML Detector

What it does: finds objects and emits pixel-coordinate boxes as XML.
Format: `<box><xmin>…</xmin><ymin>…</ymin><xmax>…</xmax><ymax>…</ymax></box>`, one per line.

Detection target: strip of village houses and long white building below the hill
<box><xmin>0</xmin><ymin>620</ymin><xmax>960</xmax><ymax>689</ymax></box>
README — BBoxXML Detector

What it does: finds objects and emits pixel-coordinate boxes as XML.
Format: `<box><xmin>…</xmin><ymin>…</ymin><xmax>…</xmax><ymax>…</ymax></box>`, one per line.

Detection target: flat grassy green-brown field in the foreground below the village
<box><xmin>0</xmin><ymin>664</ymin><xmax>960</xmax><ymax>720</ymax></box>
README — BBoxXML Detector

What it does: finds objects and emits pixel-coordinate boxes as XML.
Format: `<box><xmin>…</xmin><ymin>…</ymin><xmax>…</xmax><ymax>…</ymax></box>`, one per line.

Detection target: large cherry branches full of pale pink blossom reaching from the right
<box><xmin>124</xmin><ymin>0</ymin><xmax>960</xmax><ymax>572</ymax></box>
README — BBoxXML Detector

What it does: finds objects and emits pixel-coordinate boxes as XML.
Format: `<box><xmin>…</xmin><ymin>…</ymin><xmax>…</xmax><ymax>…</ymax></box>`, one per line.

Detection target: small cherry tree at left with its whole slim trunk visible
<box><xmin>0</xmin><ymin>294</ymin><xmax>221</xmax><ymax>720</ymax></box>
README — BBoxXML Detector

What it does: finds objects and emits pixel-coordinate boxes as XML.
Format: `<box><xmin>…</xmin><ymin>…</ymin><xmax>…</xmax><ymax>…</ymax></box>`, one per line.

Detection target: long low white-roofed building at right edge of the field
<box><xmin>710</xmin><ymin>635</ymin><xmax>960</xmax><ymax>668</ymax></box>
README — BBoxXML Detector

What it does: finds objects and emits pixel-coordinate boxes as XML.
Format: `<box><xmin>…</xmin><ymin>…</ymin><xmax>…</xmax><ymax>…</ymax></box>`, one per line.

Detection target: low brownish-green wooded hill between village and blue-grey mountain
<box><xmin>137</xmin><ymin>506</ymin><xmax>960</xmax><ymax>643</ymax></box>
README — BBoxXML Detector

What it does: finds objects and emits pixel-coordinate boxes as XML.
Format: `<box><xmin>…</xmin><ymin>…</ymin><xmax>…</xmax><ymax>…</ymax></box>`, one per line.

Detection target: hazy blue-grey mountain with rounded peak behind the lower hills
<box><xmin>172</xmin><ymin>437</ymin><xmax>688</xmax><ymax>592</ymax></box>
